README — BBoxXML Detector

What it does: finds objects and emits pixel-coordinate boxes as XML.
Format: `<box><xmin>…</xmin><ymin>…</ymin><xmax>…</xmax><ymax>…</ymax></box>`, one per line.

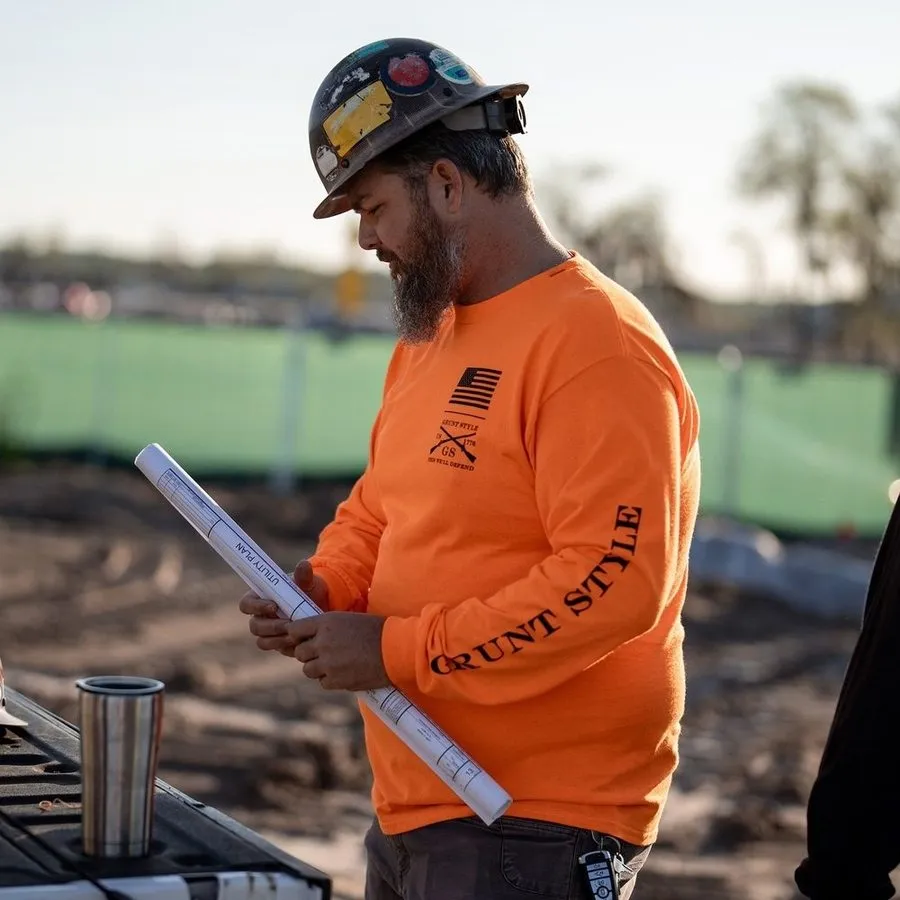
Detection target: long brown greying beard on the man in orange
<box><xmin>378</xmin><ymin>197</ymin><xmax>465</xmax><ymax>344</ymax></box>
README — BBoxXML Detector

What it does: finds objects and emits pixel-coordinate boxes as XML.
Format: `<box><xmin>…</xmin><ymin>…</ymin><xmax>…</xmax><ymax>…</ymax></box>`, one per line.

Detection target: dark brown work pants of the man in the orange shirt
<box><xmin>365</xmin><ymin>817</ymin><xmax>650</xmax><ymax>900</ymax></box>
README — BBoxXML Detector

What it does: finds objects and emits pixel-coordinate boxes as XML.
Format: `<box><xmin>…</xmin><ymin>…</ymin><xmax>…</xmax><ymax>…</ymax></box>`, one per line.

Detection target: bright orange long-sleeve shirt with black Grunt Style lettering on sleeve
<box><xmin>312</xmin><ymin>255</ymin><xmax>700</xmax><ymax>844</ymax></box>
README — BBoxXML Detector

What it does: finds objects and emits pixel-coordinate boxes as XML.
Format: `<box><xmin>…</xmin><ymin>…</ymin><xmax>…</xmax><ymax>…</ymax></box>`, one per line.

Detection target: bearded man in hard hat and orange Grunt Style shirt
<box><xmin>240</xmin><ymin>39</ymin><xmax>700</xmax><ymax>900</ymax></box>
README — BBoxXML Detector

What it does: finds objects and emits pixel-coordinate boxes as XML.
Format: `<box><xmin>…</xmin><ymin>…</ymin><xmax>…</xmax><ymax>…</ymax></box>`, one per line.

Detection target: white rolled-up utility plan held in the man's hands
<box><xmin>134</xmin><ymin>444</ymin><xmax>512</xmax><ymax>825</ymax></box>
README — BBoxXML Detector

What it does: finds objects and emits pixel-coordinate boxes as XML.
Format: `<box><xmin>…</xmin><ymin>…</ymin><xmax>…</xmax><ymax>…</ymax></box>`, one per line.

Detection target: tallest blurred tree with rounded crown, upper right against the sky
<box><xmin>737</xmin><ymin>82</ymin><xmax>857</xmax><ymax>292</ymax></box>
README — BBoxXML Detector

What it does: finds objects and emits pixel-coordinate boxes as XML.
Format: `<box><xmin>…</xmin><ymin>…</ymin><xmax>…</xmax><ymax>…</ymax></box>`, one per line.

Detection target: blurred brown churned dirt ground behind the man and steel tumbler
<box><xmin>0</xmin><ymin>462</ymin><xmax>875</xmax><ymax>900</ymax></box>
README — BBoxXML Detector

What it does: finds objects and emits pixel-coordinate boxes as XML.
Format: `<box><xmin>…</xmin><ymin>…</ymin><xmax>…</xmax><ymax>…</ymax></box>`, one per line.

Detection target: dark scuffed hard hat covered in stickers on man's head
<box><xmin>309</xmin><ymin>38</ymin><xmax>528</xmax><ymax>219</ymax></box>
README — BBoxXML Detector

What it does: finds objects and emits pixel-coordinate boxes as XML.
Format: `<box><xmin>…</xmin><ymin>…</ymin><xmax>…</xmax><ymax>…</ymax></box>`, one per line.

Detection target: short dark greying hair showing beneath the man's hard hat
<box><xmin>376</xmin><ymin>122</ymin><xmax>531</xmax><ymax>198</ymax></box>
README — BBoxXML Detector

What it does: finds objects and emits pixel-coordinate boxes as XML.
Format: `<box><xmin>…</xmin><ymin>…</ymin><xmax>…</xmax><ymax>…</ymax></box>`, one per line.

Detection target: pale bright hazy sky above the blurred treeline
<box><xmin>0</xmin><ymin>0</ymin><xmax>900</xmax><ymax>299</ymax></box>
